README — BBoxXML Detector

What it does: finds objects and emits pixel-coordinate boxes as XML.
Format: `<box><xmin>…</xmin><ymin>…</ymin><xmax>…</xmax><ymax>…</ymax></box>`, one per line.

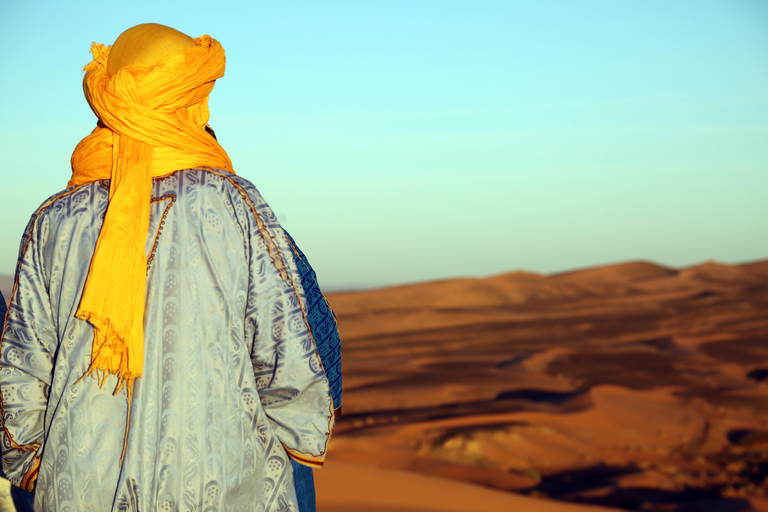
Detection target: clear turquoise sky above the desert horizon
<box><xmin>0</xmin><ymin>0</ymin><xmax>768</xmax><ymax>290</ymax></box>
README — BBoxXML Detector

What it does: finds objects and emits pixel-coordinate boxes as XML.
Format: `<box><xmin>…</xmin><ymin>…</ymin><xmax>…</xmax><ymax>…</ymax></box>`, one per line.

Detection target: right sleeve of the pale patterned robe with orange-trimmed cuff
<box><xmin>236</xmin><ymin>180</ymin><xmax>334</xmax><ymax>467</ymax></box>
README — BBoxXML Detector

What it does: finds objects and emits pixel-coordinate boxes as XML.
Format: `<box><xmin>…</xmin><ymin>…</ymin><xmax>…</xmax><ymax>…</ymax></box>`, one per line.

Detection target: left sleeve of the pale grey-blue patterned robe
<box><xmin>0</xmin><ymin>213</ymin><xmax>58</xmax><ymax>490</ymax></box>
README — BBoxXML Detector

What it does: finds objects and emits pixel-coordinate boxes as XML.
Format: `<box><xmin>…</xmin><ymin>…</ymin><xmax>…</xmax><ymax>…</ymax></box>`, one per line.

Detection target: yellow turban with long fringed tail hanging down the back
<box><xmin>69</xmin><ymin>24</ymin><xmax>233</xmax><ymax>394</ymax></box>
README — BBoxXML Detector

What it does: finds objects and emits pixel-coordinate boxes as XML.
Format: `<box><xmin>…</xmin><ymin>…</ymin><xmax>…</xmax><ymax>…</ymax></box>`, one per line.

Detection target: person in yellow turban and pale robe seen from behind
<box><xmin>0</xmin><ymin>24</ymin><xmax>340</xmax><ymax>511</ymax></box>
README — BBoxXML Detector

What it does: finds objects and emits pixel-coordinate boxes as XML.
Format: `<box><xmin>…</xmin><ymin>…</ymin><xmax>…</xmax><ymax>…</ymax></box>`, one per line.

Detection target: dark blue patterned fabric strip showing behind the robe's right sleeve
<box><xmin>285</xmin><ymin>231</ymin><xmax>341</xmax><ymax>418</ymax></box>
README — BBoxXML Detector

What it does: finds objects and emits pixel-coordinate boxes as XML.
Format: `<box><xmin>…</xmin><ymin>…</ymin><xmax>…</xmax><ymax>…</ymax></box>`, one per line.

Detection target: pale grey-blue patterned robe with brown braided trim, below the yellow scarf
<box><xmin>0</xmin><ymin>169</ymin><xmax>334</xmax><ymax>512</ymax></box>
